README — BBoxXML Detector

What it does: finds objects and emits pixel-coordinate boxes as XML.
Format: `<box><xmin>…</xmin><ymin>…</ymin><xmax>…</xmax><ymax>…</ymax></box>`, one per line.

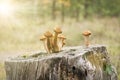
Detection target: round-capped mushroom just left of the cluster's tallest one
<box><xmin>44</xmin><ymin>31</ymin><xmax>53</xmax><ymax>53</ymax></box>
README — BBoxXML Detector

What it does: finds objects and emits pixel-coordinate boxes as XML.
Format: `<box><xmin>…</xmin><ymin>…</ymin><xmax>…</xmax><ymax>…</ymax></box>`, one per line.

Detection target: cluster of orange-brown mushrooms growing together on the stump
<box><xmin>40</xmin><ymin>27</ymin><xmax>66</xmax><ymax>53</ymax></box>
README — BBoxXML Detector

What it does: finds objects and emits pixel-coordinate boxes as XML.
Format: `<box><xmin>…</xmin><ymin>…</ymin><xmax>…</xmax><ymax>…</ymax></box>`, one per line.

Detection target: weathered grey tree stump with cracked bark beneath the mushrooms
<box><xmin>5</xmin><ymin>45</ymin><xmax>117</xmax><ymax>80</ymax></box>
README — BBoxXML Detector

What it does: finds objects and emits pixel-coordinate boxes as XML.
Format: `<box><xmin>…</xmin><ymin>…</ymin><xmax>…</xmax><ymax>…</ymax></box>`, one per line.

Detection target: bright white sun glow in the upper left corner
<box><xmin>0</xmin><ymin>2</ymin><xmax>14</xmax><ymax>16</ymax></box>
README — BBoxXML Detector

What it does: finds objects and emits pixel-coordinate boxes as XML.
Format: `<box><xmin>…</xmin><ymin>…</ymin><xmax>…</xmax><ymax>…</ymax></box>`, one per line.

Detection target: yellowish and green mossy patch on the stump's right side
<box><xmin>86</xmin><ymin>53</ymin><xmax>112</xmax><ymax>74</ymax></box>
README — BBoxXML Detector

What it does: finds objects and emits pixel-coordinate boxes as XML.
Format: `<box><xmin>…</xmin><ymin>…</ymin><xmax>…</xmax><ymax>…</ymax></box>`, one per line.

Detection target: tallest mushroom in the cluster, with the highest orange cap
<box><xmin>53</xmin><ymin>27</ymin><xmax>62</xmax><ymax>52</ymax></box>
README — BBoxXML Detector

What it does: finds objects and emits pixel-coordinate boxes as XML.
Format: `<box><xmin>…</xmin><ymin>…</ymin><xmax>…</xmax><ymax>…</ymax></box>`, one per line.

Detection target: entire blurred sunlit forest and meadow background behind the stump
<box><xmin>0</xmin><ymin>0</ymin><xmax>120</xmax><ymax>80</ymax></box>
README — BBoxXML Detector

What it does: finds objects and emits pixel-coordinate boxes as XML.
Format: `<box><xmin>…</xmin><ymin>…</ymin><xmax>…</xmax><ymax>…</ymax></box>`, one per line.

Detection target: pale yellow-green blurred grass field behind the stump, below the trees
<box><xmin>0</xmin><ymin>18</ymin><xmax>120</xmax><ymax>80</ymax></box>
